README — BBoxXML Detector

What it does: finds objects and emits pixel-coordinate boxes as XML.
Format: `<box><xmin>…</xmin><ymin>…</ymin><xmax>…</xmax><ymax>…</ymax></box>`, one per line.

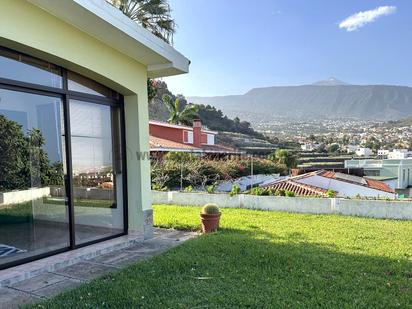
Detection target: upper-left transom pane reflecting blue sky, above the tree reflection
<box><xmin>0</xmin><ymin>49</ymin><xmax>62</xmax><ymax>88</ymax></box>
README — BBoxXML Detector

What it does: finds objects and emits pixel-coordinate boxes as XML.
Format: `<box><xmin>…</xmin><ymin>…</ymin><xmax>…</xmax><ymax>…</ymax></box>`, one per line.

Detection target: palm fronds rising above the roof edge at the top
<box><xmin>106</xmin><ymin>0</ymin><xmax>176</xmax><ymax>44</ymax></box>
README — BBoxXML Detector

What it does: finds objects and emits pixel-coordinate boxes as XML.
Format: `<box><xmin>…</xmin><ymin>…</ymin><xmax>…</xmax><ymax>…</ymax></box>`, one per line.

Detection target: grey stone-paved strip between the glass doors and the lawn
<box><xmin>0</xmin><ymin>229</ymin><xmax>196</xmax><ymax>309</ymax></box>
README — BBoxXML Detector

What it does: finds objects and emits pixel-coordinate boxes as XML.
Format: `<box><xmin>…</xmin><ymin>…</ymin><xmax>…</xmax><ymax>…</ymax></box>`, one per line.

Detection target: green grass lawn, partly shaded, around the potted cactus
<box><xmin>29</xmin><ymin>206</ymin><xmax>412</xmax><ymax>308</ymax></box>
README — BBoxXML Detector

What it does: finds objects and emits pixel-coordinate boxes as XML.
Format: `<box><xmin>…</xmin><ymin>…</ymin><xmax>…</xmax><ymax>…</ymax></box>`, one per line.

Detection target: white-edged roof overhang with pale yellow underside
<box><xmin>28</xmin><ymin>0</ymin><xmax>190</xmax><ymax>78</ymax></box>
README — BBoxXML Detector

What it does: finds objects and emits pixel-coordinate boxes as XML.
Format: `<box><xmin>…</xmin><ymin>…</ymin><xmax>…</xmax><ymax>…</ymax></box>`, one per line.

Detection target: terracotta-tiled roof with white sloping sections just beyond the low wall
<box><xmin>265</xmin><ymin>170</ymin><xmax>396</xmax><ymax>198</ymax></box>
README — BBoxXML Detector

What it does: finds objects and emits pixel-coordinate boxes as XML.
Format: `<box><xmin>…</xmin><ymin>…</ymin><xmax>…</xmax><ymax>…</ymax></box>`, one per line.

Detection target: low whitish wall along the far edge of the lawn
<box><xmin>152</xmin><ymin>191</ymin><xmax>412</xmax><ymax>220</ymax></box>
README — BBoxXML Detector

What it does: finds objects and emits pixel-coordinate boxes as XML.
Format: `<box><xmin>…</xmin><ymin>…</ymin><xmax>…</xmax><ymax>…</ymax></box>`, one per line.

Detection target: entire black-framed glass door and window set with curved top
<box><xmin>0</xmin><ymin>47</ymin><xmax>127</xmax><ymax>269</ymax></box>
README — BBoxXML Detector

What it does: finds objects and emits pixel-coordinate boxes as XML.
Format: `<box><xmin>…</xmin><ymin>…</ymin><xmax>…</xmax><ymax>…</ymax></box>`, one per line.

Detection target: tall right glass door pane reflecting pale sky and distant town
<box><xmin>70</xmin><ymin>100</ymin><xmax>124</xmax><ymax>244</ymax></box>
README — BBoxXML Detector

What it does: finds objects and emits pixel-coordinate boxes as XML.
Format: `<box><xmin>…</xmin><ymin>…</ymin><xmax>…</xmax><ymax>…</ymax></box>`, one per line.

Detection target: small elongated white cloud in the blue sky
<box><xmin>339</xmin><ymin>6</ymin><xmax>396</xmax><ymax>32</ymax></box>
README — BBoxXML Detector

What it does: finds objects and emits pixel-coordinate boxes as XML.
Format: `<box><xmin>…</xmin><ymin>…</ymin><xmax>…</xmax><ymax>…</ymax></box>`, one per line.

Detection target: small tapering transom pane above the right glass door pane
<box><xmin>67</xmin><ymin>71</ymin><xmax>118</xmax><ymax>99</ymax></box>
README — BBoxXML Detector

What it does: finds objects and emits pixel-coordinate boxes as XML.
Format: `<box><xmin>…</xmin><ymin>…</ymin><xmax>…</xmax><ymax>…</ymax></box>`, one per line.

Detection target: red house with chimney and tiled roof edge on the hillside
<box><xmin>149</xmin><ymin>119</ymin><xmax>243</xmax><ymax>156</ymax></box>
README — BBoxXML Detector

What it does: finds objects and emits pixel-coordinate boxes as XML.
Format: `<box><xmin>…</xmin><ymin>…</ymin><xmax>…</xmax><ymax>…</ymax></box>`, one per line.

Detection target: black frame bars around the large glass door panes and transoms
<box><xmin>0</xmin><ymin>46</ymin><xmax>129</xmax><ymax>270</ymax></box>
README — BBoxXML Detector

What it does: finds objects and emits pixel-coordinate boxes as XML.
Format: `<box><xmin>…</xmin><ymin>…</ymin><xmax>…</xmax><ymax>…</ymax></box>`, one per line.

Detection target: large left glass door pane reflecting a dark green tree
<box><xmin>0</xmin><ymin>89</ymin><xmax>69</xmax><ymax>265</ymax></box>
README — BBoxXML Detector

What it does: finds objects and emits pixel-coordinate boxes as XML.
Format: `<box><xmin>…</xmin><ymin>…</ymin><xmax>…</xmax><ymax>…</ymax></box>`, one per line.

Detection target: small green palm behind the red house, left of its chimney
<box><xmin>162</xmin><ymin>94</ymin><xmax>199</xmax><ymax>125</ymax></box>
